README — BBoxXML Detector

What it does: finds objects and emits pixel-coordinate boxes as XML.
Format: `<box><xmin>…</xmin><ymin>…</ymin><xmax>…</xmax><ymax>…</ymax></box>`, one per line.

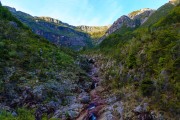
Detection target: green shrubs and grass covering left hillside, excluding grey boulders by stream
<box><xmin>0</xmin><ymin>6</ymin><xmax>88</xmax><ymax>120</ymax></box>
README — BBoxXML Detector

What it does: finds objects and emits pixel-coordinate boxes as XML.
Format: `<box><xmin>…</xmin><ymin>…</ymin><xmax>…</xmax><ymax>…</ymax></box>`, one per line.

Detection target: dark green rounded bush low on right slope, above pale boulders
<box><xmin>140</xmin><ymin>79</ymin><xmax>155</xmax><ymax>96</ymax></box>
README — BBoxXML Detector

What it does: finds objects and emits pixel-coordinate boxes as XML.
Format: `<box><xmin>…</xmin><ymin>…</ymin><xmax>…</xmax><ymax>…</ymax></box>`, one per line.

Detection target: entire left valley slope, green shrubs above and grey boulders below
<box><xmin>0</xmin><ymin>6</ymin><xmax>90</xmax><ymax>120</ymax></box>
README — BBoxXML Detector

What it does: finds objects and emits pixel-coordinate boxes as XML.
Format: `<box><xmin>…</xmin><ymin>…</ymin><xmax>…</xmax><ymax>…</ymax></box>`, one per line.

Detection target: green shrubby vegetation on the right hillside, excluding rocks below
<box><xmin>90</xmin><ymin>4</ymin><xmax>180</xmax><ymax>116</ymax></box>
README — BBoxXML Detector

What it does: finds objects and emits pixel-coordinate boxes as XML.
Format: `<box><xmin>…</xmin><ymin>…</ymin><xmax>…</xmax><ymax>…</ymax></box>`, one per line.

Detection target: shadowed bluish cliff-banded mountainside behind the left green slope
<box><xmin>7</xmin><ymin>7</ymin><xmax>92</xmax><ymax>50</ymax></box>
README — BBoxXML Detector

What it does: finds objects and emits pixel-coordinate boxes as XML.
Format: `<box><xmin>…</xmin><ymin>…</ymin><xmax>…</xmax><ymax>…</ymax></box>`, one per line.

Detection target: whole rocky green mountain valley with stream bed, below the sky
<box><xmin>0</xmin><ymin>0</ymin><xmax>180</xmax><ymax>120</ymax></box>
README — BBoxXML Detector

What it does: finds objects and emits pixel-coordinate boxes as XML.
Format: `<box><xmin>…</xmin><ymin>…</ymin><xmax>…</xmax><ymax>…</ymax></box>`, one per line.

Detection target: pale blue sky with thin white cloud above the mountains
<box><xmin>1</xmin><ymin>0</ymin><xmax>168</xmax><ymax>26</ymax></box>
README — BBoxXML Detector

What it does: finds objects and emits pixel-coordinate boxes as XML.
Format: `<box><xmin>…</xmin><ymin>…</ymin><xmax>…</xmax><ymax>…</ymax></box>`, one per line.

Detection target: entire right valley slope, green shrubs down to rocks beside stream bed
<box><xmin>86</xmin><ymin>4</ymin><xmax>180</xmax><ymax>120</ymax></box>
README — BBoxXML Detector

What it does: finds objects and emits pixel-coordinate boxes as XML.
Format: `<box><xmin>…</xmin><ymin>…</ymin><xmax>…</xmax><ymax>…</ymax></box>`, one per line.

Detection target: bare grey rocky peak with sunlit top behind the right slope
<box><xmin>100</xmin><ymin>8</ymin><xmax>155</xmax><ymax>42</ymax></box>
